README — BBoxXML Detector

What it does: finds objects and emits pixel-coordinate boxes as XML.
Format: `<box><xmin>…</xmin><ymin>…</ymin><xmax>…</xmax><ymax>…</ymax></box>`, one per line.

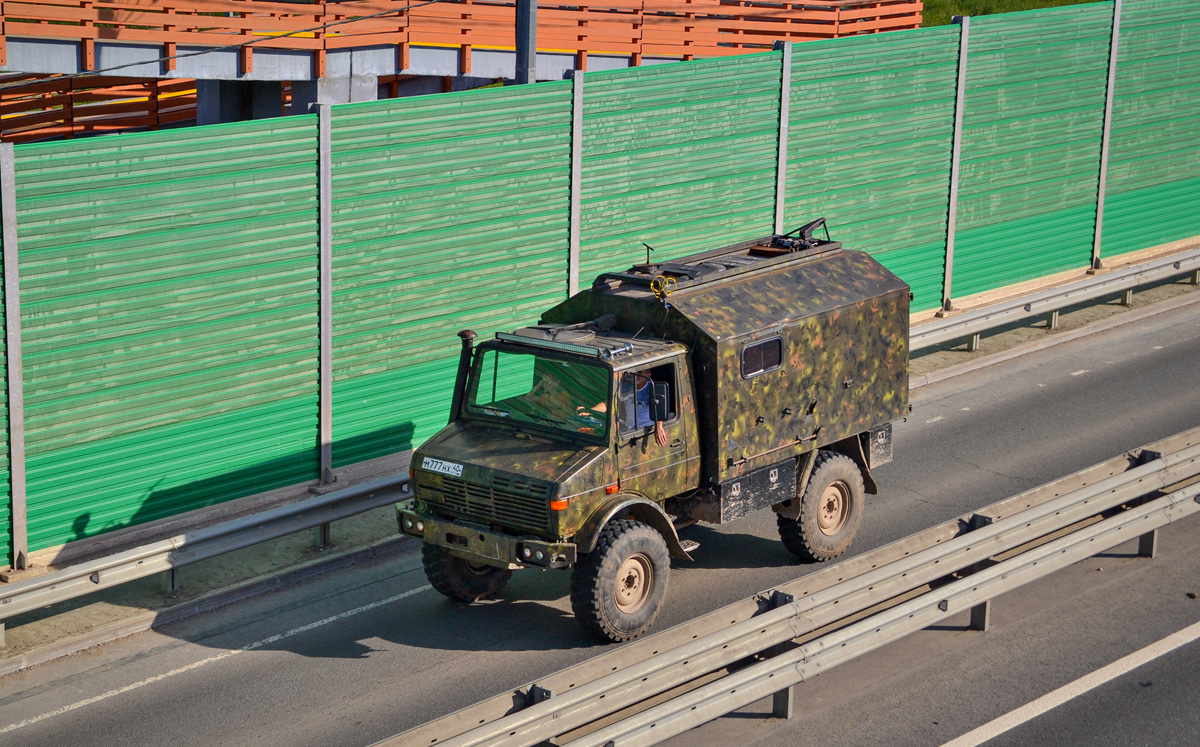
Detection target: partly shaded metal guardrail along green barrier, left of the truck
<box><xmin>0</xmin><ymin>476</ymin><xmax>409</xmax><ymax>629</ymax></box>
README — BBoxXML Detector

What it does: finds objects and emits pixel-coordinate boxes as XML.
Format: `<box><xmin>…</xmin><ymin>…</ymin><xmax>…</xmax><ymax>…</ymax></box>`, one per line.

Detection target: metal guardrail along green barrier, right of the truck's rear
<box><xmin>910</xmin><ymin>249</ymin><xmax>1200</xmax><ymax>351</ymax></box>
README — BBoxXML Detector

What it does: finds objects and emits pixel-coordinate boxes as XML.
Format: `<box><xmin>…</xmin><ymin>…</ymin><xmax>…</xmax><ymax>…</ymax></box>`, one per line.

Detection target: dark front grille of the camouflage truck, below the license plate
<box><xmin>442</xmin><ymin>476</ymin><xmax>550</xmax><ymax>532</ymax></box>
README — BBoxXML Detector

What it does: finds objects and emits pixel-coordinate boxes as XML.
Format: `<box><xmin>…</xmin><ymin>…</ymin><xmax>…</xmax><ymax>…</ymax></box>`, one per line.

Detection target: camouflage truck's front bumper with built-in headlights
<box><xmin>396</xmin><ymin>501</ymin><xmax>576</xmax><ymax>569</ymax></box>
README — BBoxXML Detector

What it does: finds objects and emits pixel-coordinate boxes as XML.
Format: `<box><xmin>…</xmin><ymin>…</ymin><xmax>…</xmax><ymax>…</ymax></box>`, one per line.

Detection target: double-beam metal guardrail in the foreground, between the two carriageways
<box><xmin>393</xmin><ymin>428</ymin><xmax>1200</xmax><ymax>747</ymax></box>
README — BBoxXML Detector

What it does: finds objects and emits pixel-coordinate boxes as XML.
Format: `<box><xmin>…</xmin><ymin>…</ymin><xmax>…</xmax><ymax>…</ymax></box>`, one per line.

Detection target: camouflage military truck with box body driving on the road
<box><xmin>398</xmin><ymin>219</ymin><xmax>911</xmax><ymax>641</ymax></box>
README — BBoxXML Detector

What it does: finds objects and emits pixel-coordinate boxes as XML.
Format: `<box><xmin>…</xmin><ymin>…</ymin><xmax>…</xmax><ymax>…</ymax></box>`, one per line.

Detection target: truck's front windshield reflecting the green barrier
<box><xmin>467</xmin><ymin>348</ymin><xmax>612</xmax><ymax>437</ymax></box>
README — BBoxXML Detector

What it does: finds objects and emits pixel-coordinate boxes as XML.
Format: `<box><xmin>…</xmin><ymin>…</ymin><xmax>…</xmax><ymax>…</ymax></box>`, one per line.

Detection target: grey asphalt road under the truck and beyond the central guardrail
<box><xmin>0</xmin><ymin>300</ymin><xmax>1200</xmax><ymax>747</ymax></box>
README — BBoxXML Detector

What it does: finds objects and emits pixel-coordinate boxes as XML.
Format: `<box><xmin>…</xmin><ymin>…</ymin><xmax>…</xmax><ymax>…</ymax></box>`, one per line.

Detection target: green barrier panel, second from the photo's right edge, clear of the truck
<box><xmin>953</xmin><ymin>2</ymin><xmax>1112</xmax><ymax>297</ymax></box>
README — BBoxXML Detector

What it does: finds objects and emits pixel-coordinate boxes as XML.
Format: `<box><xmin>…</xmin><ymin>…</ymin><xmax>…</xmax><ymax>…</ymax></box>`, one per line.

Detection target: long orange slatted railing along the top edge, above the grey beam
<box><xmin>0</xmin><ymin>0</ymin><xmax>922</xmax><ymax>77</ymax></box>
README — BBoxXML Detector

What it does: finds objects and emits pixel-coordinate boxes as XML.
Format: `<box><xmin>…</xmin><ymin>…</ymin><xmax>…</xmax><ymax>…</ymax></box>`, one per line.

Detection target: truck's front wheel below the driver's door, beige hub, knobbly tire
<box><xmin>571</xmin><ymin>519</ymin><xmax>671</xmax><ymax>643</ymax></box>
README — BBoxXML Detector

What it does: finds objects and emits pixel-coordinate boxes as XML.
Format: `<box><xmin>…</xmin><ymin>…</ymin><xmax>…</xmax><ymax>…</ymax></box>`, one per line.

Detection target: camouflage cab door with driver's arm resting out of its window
<box><xmin>617</xmin><ymin>355</ymin><xmax>700</xmax><ymax>502</ymax></box>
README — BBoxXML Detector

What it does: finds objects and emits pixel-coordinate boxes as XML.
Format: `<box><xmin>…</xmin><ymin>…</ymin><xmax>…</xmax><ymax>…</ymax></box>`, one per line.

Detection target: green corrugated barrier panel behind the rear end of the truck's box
<box><xmin>784</xmin><ymin>26</ymin><xmax>959</xmax><ymax>310</ymax></box>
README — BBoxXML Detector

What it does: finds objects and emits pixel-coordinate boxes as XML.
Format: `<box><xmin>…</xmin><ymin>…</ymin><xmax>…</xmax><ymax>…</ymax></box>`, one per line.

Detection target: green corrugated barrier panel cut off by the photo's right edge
<box><xmin>1102</xmin><ymin>0</ymin><xmax>1200</xmax><ymax>257</ymax></box>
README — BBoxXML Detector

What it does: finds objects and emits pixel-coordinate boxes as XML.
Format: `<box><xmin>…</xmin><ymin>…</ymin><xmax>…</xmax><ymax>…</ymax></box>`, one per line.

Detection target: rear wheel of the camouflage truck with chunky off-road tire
<box><xmin>775</xmin><ymin>452</ymin><xmax>866</xmax><ymax>562</ymax></box>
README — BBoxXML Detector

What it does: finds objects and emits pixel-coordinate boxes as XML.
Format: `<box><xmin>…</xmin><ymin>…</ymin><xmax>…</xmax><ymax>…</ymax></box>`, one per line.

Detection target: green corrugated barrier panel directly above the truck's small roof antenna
<box><xmin>580</xmin><ymin>52</ymin><xmax>781</xmax><ymax>285</ymax></box>
